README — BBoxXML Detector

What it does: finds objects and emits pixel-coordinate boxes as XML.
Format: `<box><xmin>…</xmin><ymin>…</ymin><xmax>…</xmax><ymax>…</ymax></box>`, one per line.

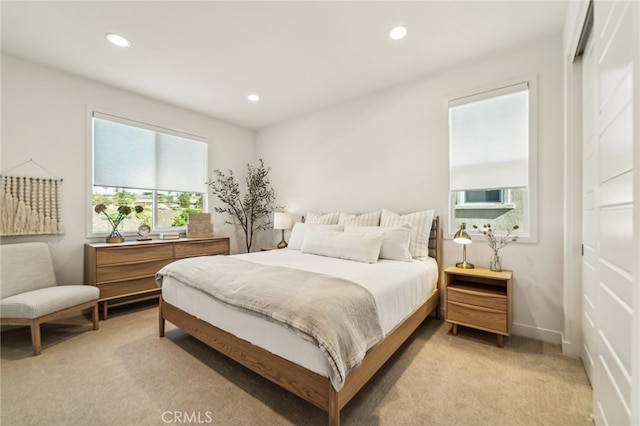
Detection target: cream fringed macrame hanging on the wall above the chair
<box><xmin>0</xmin><ymin>159</ymin><xmax>64</xmax><ymax>236</ymax></box>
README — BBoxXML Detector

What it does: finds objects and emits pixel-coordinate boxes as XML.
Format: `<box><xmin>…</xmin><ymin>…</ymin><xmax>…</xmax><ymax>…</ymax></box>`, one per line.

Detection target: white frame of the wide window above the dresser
<box><xmin>85</xmin><ymin>106</ymin><xmax>209</xmax><ymax>238</ymax></box>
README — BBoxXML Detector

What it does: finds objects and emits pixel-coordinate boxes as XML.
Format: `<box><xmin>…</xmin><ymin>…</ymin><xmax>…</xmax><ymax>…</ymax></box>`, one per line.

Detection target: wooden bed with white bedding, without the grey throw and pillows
<box><xmin>158</xmin><ymin>217</ymin><xmax>442</xmax><ymax>426</ymax></box>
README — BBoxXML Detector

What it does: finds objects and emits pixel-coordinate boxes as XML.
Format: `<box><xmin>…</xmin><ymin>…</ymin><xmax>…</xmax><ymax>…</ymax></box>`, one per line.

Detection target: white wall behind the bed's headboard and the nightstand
<box><xmin>256</xmin><ymin>35</ymin><xmax>564</xmax><ymax>343</ymax></box>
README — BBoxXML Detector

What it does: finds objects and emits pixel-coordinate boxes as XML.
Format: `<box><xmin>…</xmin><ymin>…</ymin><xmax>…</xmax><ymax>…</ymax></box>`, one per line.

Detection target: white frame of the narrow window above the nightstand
<box><xmin>445</xmin><ymin>74</ymin><xmax>538</xmax><ymax>243</ymax></box>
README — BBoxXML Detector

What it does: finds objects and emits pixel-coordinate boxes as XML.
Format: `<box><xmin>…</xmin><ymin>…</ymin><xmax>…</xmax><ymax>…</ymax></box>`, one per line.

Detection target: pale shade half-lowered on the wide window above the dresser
<box><xmin>93</xmin><ymin>114</ymin><xmax>207</xmax><ymax>193</ymax></box>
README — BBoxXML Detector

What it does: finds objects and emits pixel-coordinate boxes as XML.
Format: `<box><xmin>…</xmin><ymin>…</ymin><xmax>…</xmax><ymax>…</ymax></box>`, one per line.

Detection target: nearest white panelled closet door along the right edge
<box><xmin>583</xmin><ymin>1</ymin><xmax>640</xmax><ymax>425</ymax></box>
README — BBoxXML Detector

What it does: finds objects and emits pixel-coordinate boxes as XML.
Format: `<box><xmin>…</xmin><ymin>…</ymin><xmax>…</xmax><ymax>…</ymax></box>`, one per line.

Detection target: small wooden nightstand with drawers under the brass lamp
<box><xmin>444</xmin><ymin>266</ymin><xmax>513</xmax><ymax>347</ymax></box>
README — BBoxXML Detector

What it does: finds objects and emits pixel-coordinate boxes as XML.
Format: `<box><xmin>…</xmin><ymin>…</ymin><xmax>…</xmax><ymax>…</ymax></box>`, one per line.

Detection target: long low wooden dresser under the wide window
<box><xmin>84</xmin><ymin>238</ymin><xmax>229</xmax><ymax>319</ymax></box>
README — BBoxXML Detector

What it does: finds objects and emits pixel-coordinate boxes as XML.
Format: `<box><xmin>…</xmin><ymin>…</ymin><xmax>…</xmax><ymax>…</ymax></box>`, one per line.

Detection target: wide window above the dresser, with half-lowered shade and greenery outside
<box><xmin>90</xmin><ymin>111</ymin><xmax>207</xmax><ymax>235</ymax></box>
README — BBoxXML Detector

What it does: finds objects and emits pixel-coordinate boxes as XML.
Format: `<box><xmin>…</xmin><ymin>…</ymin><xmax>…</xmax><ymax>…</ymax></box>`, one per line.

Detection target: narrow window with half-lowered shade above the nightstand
<box><xmin>449</xmin><ymin>82</ymin><xmax>535</xmax><ymax>237</ymax></box>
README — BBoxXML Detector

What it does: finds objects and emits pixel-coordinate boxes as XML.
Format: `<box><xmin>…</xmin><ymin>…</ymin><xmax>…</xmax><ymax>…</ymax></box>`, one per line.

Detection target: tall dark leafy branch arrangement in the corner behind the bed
<box><xmin>207</xmin><ymin>159</ymin><xmax>282</xmax><ymax>253</ymax></box>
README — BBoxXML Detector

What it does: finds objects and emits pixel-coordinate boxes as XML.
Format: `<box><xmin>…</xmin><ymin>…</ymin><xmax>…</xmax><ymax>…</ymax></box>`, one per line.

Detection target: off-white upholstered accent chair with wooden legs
<box><xmin>0</xmin><ymin>243</ymin><xmax>100</xmax><ymax>355</ymax></box>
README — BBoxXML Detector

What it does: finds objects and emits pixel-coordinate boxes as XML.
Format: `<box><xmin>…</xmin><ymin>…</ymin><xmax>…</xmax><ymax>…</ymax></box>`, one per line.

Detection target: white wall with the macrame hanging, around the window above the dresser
<box><xmin>1</xmin><ymin>56</ymin><xmax>254</xmax><ymax>284</ymax></box>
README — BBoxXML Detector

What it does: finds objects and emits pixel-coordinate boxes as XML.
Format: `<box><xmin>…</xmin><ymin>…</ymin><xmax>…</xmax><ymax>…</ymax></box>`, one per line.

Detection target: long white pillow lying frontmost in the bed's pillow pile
<box><xmin>300</xmin><ymin>229</ymin><xmax>383</xmax><ymax>263</ymax></box>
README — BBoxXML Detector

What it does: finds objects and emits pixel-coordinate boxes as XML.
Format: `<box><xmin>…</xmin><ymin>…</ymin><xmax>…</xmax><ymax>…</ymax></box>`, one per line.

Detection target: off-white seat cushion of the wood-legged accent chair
<box><xmin>0</xmin><ymin>285</ymin><xmax>100</xmax><ymax>319</ymax></box>
